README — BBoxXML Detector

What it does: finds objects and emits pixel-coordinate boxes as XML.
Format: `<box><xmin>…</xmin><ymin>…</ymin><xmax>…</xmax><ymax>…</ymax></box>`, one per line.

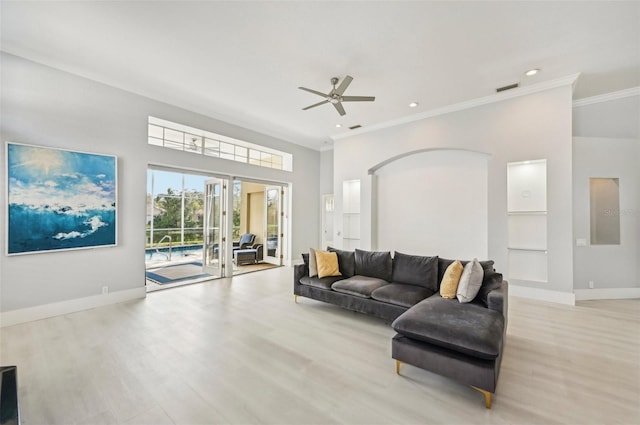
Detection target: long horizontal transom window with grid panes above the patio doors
<box><xmin>148</xmin><ymin>117</ymin><xmax>293</xmax><ymax>171</ymax></box>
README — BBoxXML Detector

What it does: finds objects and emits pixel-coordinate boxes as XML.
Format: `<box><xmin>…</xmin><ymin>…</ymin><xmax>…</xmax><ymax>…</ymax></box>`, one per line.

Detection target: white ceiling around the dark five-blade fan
<box><xmin>0</xmin><ymin>0</ymin><xmax>640</xmax><ymax>149</ymax></box>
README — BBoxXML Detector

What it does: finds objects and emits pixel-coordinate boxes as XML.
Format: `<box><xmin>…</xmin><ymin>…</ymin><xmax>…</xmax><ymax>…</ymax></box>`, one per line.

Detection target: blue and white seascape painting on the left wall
<box><xmin>7</xmin><ymin>143</ymin><xmax>117</xmax><ymax>255</ymax></box>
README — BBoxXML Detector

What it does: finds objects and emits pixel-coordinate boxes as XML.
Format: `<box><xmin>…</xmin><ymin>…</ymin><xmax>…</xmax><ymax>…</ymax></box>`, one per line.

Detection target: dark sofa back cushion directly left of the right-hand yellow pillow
<box><xmin>391</xmin><ymin>251</ymin><xmax>438</xmax><ymax>292</ymax></box>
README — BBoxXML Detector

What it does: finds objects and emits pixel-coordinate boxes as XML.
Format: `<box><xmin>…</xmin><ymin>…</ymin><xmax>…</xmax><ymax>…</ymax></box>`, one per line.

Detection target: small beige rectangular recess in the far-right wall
<box><xmin>589</xmin><ymin>178</ymin><xmax>620</xmax><ymax>245</ymax></box>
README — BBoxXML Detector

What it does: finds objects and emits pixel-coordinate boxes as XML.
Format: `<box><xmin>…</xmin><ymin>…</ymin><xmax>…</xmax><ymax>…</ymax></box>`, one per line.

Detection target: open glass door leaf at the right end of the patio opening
<box><xmin>264</xmin><ymin>186</ymin><xmax>284</xmax><ymax>266</ymax></box>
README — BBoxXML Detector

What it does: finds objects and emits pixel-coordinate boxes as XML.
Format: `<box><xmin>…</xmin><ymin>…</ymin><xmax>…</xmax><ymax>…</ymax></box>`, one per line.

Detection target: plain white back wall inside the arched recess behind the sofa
<box><xmin>372</xmin><ymin>150</ymin><xmax>488</xmax><ymax>259</ymax></box>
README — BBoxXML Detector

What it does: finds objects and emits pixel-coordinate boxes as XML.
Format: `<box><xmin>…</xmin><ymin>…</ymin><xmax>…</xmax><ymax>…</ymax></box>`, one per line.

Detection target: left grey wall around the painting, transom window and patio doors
<box><xmin>0</xmin><ymin>53</ymin><xmax>320</xmax><ymax>313</ymax></box>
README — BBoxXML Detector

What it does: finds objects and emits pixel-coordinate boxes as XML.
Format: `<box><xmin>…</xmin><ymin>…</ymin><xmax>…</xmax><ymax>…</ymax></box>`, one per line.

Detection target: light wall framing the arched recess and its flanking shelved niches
<box><xmin>334</xmin><ymin>83</ymin><xmax>573</xmax><ymax>295</ymax></box>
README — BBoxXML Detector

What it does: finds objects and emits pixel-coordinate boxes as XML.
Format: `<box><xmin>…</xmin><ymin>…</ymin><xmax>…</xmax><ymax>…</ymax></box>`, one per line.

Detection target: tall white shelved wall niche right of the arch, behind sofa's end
<box><xmin>507</xmin><ymin>159</ymin><xmax>547</xmax><ymax>282</ymax></box>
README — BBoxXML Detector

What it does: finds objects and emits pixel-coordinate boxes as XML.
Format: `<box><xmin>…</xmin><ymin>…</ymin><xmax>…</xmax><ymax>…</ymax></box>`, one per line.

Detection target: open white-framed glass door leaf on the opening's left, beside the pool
<box><xmin>202</xmin><ymin>179</ymin><xmax>226</xmax><ymax>276</ymax></box>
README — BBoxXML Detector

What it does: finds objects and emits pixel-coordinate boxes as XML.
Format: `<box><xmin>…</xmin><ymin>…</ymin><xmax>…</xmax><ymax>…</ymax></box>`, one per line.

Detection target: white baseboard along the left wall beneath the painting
<box><xmin>0</xmin><ymin>286</ymin><xmax>147</xmax><ymax>328</ymax></box>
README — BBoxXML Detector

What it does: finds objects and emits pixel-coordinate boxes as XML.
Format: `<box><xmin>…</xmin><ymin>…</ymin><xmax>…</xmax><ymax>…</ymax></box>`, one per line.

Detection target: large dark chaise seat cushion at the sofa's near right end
<box><xmin>391</xmin><ymin>295</ymin><xmax>504</xmax><ymax>360</ymax></box>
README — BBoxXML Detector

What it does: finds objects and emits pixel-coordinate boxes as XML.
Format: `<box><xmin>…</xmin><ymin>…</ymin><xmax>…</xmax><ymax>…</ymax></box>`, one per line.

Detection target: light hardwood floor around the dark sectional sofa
<box><xmin>0</xmin><ymin>267</ymin><xmax>640</xmax><ymax>425</ymax></box>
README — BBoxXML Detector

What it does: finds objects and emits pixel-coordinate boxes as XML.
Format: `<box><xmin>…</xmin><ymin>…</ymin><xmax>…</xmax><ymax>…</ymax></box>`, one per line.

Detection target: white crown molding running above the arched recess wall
<box><xmin>332</xmin><ymin>73</ymin><xmax>580</xmax><ymax>140</ymax></box>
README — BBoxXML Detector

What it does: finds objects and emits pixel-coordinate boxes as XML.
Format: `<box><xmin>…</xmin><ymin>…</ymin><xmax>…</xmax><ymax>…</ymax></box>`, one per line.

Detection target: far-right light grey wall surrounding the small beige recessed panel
<box><xmin>573</xmin><ymin>95</ymin><xmax>640</xmax><ymax>298</ymax></box>
